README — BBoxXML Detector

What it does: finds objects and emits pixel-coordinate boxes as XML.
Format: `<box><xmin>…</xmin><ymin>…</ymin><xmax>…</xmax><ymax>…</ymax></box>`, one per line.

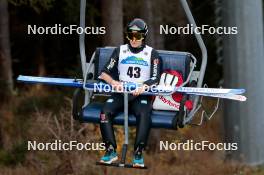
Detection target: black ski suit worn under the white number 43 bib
<box><xmin>100</xmin><ymin>44</ymin><xmax>161</xmax><ymax>150</ymax></box>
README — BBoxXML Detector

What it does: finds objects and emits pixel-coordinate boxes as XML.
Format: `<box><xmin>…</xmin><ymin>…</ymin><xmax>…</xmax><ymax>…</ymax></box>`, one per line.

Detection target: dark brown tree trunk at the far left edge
<box><xmin>0</xmin><ymin>0</ymin><xmax>13</xmax><ymax>102</ymax></box>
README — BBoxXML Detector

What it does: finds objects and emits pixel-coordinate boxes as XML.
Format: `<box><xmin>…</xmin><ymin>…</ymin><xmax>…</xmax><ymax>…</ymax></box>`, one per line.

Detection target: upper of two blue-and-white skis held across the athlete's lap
<box><xmin>17</xmin><ymin>75</ymin><xmax>245</xmax><ymax>98</ymax></box>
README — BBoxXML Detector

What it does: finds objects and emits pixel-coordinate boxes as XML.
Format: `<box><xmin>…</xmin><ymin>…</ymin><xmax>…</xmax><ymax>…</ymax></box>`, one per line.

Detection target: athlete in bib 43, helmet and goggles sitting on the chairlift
<box><xmin>99</xmin><ymin>18</ymin><xmax>161</xmax><ymax>167</ymax></box>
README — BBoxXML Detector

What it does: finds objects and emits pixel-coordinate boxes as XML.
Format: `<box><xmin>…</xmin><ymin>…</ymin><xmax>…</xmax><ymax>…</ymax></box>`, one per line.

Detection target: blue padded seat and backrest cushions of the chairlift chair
<box><xmin>79</xmin><ymin>47</ymin><xmax>192</xmax><ymax>129</ymax></box>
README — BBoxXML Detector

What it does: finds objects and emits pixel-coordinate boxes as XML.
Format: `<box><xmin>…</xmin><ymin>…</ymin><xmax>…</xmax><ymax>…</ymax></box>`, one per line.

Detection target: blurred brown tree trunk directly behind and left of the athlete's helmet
<box><xmin>102</xmin><ymin>0</ymin><xmax>124</xmax><ymax>46</ymax></box>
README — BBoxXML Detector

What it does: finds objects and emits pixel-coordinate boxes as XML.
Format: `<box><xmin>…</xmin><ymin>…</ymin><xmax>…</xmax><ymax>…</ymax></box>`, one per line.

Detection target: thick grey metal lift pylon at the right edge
<box><xmin>223</xmin><ymin>0</ymin><xmax>264</xmax><ymax>165</ymax></box>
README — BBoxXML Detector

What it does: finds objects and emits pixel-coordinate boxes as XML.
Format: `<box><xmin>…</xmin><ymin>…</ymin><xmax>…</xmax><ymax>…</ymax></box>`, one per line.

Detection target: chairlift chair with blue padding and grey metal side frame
<box><xmin>75</xmin><ymin>0</ymin><xmax>211</xmax><ymax>129</ymax></box>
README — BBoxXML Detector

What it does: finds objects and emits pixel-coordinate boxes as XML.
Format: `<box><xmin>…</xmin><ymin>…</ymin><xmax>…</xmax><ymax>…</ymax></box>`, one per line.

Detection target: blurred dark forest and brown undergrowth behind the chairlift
<box><xmin>0</xmin><ymin>0</ymin><xmax>264</xmax><ymax>175</ymax></box>
